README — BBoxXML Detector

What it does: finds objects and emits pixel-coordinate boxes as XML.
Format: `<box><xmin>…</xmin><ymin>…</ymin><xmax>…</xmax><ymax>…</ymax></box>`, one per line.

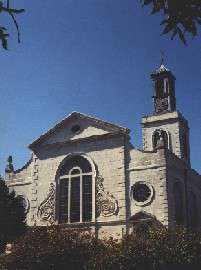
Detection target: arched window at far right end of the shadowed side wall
<box><xmin>188</xmin><ymin>191</ymin><xmax>198</xmax><ymax>228</ymax></box>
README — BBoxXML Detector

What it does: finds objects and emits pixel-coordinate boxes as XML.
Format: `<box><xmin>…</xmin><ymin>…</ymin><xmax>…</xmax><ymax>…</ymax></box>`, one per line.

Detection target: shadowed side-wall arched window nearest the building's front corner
<box><xmin>173</xmin><ymin>182</ymin><xmax>184</xmax><ymax>225</ymax></box>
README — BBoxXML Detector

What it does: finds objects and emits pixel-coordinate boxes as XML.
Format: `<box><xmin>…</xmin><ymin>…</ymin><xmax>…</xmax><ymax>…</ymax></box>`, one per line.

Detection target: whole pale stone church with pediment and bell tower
<box><xmin>5</xmin><ymin>64</ymin><xmax>201</xmax><ymax>237</ymax></box>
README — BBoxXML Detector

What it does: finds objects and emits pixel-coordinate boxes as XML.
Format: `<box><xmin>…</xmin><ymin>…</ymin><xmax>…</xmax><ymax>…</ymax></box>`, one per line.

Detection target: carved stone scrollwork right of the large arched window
<box><xmin>96</xmin><ymin>175</ymin><xmax>119</xmax><ymax>217</ymax></box>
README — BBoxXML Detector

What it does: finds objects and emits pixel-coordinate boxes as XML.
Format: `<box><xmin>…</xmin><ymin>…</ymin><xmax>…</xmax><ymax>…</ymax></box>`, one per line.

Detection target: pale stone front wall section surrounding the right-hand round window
<box><xmin>129</xmin><ymin>149</ymin><xmax>168</xmax><ymax>226</ymax></box>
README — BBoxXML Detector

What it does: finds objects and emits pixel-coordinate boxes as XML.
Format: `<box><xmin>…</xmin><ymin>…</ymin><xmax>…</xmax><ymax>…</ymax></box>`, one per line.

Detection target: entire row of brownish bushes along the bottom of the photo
<box><xmin>0</xmin><ymin>226</ymin><xmax>201</xmax><ymax>270</ymax></box>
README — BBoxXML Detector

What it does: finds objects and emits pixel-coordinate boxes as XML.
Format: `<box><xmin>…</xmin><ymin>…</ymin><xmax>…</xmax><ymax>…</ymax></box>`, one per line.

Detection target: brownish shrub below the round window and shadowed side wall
<box><xmin>91</xmin><ymin>228</ymin><xmax>201</xmax><ymax>270</ymax></box>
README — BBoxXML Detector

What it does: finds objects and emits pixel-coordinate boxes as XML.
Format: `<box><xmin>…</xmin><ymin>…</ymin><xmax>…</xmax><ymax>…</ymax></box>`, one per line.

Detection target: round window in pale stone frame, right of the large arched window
<box><xmin>132</xmin><ymin>182</ymin><xmax>153</xmax><ymax>205</ymax></box>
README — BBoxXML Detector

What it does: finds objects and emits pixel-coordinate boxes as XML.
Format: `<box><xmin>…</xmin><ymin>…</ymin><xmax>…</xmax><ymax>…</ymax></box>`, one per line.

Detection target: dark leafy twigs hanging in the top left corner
<box><xmin>0</xmin><ymin>0</ymin><xmax>24</xmax><ymax>50</ymax></box>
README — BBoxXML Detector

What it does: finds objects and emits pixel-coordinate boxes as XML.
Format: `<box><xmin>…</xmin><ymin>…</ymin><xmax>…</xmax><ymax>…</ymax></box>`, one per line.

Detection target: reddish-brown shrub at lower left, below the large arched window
<box><xmin>0</xmin><ymin>226</ymin><xmax>107</xmax><ymax>270</ymax></box>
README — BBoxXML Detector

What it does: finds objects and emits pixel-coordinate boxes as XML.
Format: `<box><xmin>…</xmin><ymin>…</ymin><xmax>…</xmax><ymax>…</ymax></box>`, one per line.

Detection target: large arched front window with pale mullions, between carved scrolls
<box><xmin>58</xmin><ymin>156</ymin><xmax>93</xmax><ymax>223</ymax></box>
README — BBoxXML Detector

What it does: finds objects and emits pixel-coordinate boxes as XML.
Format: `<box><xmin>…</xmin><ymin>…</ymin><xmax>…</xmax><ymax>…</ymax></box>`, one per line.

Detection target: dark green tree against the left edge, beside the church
<box><xmin>0</xmin><ymin>177</ymin><xmax>26</xmax><ymax>253</ymax></box>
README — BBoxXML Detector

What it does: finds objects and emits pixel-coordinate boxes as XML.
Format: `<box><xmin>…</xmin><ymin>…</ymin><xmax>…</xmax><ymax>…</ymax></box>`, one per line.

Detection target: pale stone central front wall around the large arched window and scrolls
<box><xmin>8</xmin><ymin>135</ymin><xmax>126</xmax><ymax>231</ymax></box>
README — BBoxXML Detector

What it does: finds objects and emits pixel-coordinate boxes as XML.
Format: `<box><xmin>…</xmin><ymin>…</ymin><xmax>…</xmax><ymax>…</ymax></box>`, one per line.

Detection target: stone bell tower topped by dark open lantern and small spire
<box><xmin>142</xmin><ymin>61</ymin><xmax>190</xmax><ymax>165</ymax></box>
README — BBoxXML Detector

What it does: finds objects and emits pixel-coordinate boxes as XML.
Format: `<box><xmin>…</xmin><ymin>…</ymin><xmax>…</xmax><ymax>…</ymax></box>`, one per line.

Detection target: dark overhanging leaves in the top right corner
<box><xmin>141</xmin><ymin>0</ymin><xmax>201</xmax><ymax>44</ymax></box>
